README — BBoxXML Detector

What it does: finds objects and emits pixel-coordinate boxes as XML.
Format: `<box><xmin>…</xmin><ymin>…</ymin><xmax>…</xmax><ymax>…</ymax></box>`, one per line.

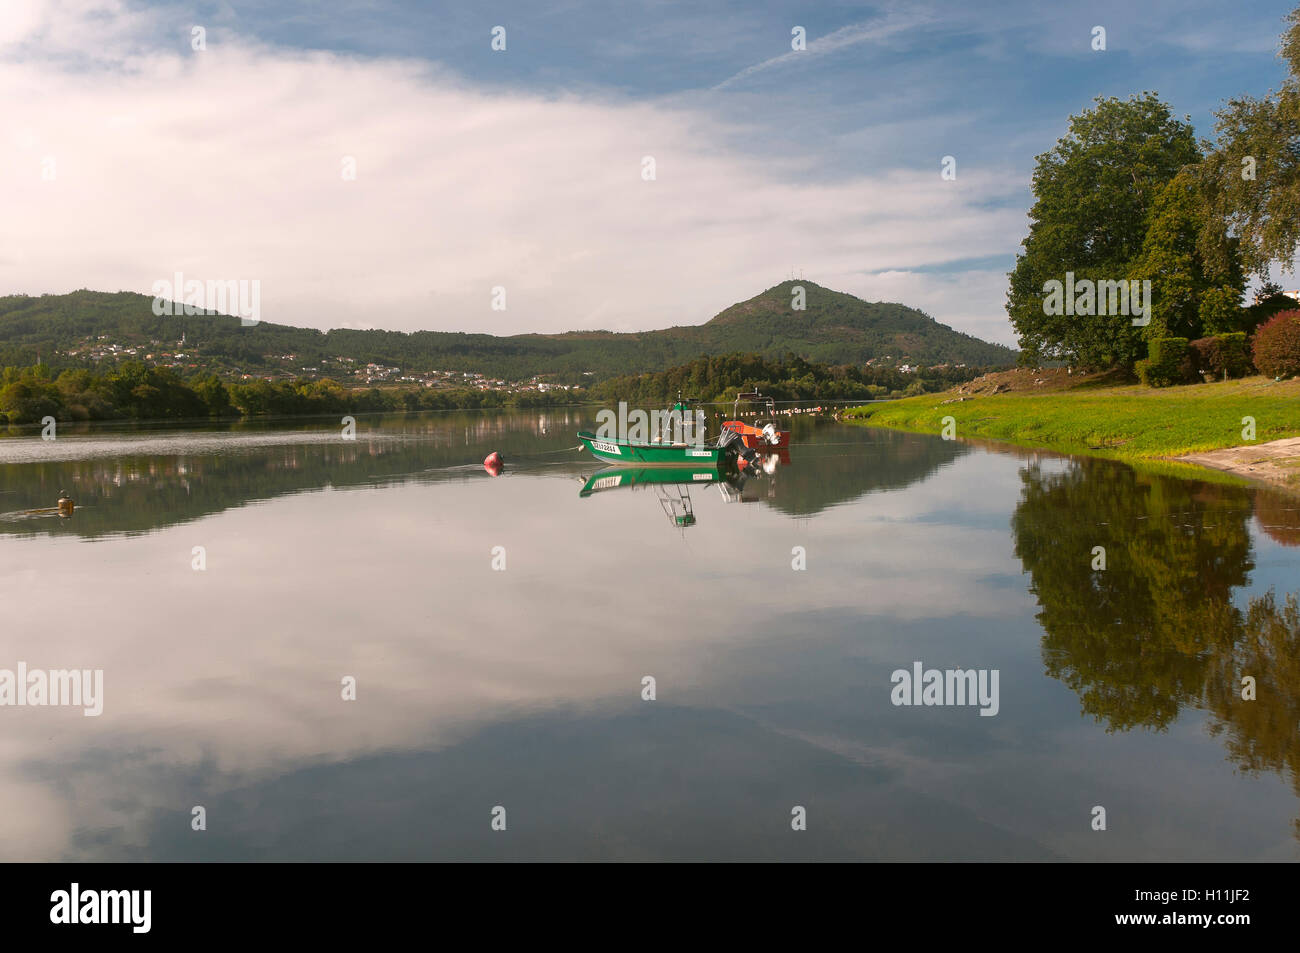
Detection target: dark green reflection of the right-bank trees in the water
<box><xmin>1011</xmin><ymin>460</ymin><xmax>1300</xmax><ymax>833</ymax></box>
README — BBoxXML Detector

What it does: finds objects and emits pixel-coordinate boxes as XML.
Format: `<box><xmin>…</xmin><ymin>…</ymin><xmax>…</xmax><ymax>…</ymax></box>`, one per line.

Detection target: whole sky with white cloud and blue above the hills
<box><xmin>0</xmin><ymin>0</ymin><xmax>1294</xmax><ymax>345</ymax></box>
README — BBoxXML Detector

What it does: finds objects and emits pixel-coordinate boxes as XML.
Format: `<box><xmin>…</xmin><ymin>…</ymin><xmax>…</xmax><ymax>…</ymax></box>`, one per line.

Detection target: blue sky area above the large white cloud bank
<box><xmin>182</xmin><ymin>0</ymin><xmax>1294</xmax><ymax>174</ymax></box>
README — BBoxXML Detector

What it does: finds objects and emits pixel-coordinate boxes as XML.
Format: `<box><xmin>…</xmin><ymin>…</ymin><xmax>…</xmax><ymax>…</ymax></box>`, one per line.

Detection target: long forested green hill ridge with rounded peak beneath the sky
<box><xmin>0</xmin><ymin>281</ymin><xmax>1015</xmax><ymax>382</ymax></box>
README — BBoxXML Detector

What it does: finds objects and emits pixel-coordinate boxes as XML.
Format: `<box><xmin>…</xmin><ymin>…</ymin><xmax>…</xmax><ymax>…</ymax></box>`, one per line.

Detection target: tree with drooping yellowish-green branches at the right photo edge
<box><xmin>1199</xmin><ymin>8</ymin><xmax>1300</xmax><ymax>274</ymax></box>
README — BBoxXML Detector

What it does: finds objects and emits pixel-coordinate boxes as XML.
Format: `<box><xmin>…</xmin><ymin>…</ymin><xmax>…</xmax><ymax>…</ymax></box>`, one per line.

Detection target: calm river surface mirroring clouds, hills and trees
<box><xmin>0</xmin><ymin>411</ymin><xmax>1300</xmax><ymax>861</ymax></box>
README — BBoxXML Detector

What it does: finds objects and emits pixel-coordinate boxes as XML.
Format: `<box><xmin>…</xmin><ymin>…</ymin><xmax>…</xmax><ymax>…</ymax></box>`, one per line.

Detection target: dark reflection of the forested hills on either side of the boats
<box><xmin>0</xmin><ymin>411</ymin><xmax>970</xmax><ymax>538</ymax></box>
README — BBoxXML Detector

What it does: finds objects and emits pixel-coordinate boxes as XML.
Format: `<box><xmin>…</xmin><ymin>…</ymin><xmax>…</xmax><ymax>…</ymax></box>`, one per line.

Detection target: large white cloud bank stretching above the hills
<box><xmin>0</xmin><ymin>0</ymin><xmax>1023</xmax><ymax>343</ymax></box>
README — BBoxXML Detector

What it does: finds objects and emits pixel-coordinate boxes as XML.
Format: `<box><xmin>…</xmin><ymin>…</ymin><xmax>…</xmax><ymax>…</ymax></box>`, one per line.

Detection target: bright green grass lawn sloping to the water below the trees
<box><xmin>848</xmin><ymin>377</ymin><xmax>1300</xmax><ymax>460</ymax></box>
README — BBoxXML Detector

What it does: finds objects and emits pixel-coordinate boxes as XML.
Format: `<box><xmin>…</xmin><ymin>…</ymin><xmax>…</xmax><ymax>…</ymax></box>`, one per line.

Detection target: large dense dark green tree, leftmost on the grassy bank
<box><xmin>1006</xmin><ymin>92</ymin><xmax>1201</xmax><ymax>367</ymax></box>
